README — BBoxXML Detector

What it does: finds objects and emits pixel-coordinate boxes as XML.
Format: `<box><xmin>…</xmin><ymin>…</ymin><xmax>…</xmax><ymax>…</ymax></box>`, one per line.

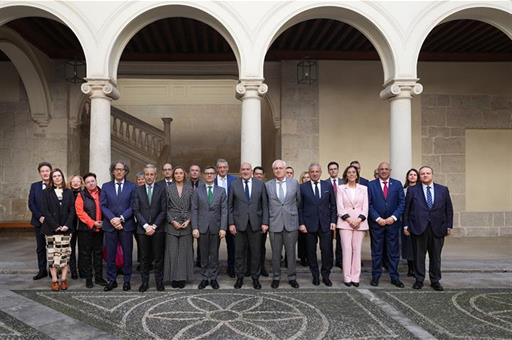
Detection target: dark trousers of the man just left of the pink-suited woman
<box><xmin>304</xmin><ymin>230</ymin><xmax>333</xmax><ymax>278</ymax></box>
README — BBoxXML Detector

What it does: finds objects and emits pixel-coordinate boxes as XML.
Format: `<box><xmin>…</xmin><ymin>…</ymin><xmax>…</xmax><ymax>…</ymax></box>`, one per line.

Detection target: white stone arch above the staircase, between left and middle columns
<box><xmin>106</xmin><ymin>3</ymin><xmax>242</xmax><ymax>82</ymax></box>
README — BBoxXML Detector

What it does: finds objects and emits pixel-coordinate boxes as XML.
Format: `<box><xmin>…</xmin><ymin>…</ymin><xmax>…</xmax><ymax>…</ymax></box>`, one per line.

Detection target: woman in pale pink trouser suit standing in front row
<box><xmin>336</xmin><ymin>166</ymin><xmax>368</xmax><ymax>287</ymax></box>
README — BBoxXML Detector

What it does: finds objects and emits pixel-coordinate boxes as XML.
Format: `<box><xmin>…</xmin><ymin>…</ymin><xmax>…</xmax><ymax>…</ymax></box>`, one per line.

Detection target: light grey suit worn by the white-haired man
<box><xmin>265</xmin><ymin>179</ymin><xmax>300</xmax><ymax>281</ymax></box>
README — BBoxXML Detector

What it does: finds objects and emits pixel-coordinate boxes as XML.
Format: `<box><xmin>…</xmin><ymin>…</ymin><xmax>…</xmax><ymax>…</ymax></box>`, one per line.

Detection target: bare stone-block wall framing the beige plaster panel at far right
<box><xmin>421</xmin><ymin>94</ymin><xmax>512</xmax><ymax>236</ymax></box>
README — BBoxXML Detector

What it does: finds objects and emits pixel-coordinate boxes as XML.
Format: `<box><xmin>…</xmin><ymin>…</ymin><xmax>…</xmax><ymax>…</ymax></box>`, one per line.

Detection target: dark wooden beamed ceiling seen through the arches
<box><xmin>0</xmin><ymin>17</ymin><xmax>512</xmax><ymax>61</ymax></box>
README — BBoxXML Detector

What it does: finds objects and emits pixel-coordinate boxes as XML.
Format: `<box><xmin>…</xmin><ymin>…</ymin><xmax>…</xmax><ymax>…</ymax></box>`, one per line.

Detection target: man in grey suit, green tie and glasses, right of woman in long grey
<box><xmin>191</xmin><ymin>166</ymin><xmax>228</xmax><ymax>289</ymax></box>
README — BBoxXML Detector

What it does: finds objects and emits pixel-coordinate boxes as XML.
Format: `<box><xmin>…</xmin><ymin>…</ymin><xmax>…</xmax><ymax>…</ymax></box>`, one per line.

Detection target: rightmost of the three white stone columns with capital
<box><xmin>380</xmin><ymin>79</ymin><xmax>423</xmax><ymax>180</ymax></box>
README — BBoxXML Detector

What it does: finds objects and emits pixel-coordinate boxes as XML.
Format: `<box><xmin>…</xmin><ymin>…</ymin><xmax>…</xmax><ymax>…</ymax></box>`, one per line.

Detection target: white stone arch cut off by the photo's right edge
<box><xmin>404</xmin><ymin>1</ymin><xmax>512</xmax><ymax>76</ymax></box>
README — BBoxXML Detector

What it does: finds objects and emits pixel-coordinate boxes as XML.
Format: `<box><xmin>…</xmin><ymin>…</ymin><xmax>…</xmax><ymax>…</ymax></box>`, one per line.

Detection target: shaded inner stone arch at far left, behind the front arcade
<box><xmin>0</xmin><ymin>27</ymin><xmax>51</xmax><ymax>127</ymax></box>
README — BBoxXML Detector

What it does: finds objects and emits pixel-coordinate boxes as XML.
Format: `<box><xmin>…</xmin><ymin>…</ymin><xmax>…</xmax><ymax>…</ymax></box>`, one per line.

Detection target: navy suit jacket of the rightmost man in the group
<box><xmin>404</xmin><ymin>183</ymin><xmax>453</xmax><ymax>237</ymax></box>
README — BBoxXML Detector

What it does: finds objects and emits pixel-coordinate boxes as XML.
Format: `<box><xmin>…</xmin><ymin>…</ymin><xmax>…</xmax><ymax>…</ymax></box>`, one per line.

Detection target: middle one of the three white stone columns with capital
<box><xmin>236</xmin><ymin>80</ymin><xmax>268</xmax><ymax>166</ymax></box>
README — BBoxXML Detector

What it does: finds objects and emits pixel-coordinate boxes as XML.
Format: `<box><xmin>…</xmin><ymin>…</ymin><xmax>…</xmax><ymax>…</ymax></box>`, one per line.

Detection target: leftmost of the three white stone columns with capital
<box><xmin>82</xmin><ymin>79</ymin><xmax>119</xmax><ymax>185</ymax></box>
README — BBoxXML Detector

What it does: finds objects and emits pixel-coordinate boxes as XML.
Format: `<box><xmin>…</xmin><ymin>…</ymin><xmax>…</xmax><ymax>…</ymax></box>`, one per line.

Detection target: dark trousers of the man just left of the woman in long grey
<box><xmin>137</xmin><ymin>232</ymin><xmax>165</xmax><ymax>282</ymax></box>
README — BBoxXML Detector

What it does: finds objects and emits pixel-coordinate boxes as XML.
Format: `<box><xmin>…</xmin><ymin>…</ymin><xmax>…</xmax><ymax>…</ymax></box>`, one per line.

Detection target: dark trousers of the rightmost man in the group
<box><xmin>412</xmin><ymin>225</ymin><xmax>444</xmax><ymax>284</ymax></box>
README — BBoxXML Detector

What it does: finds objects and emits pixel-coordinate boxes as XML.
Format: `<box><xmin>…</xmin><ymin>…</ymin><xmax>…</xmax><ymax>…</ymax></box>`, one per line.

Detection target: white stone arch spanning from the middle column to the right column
<box><xmin>257</xmin><ymin>2</ymin><xmax>396</xmax><ymax>83</ymax></box>
